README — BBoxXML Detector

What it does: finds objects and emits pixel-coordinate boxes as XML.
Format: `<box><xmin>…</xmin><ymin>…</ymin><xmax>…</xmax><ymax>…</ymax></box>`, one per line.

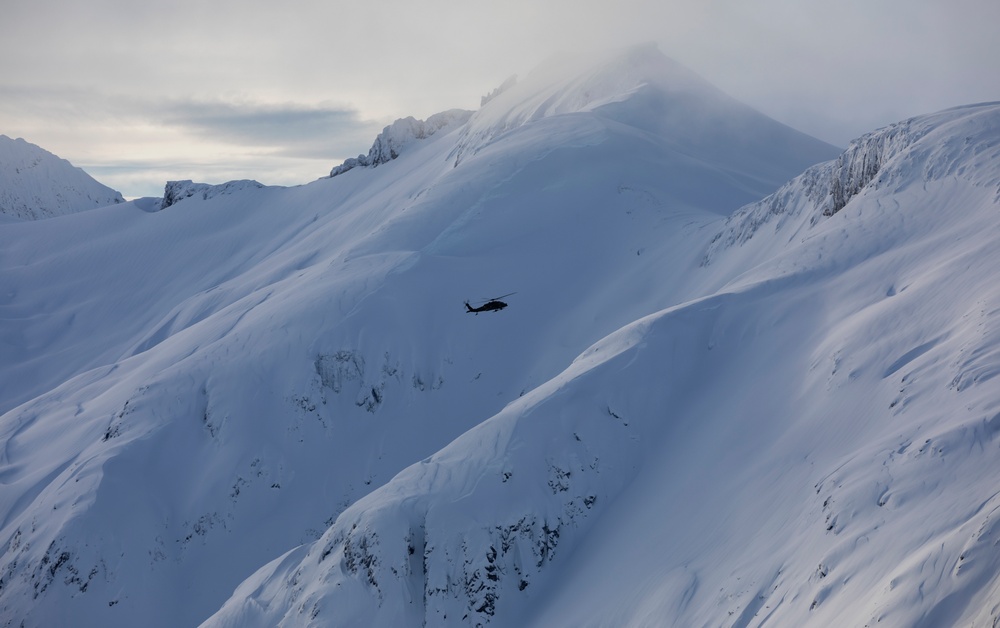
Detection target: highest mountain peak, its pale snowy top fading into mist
<box><xmin>450</xmin><ymin>44</ymin><xmax>840</xmax><ymax>201</ymax></box>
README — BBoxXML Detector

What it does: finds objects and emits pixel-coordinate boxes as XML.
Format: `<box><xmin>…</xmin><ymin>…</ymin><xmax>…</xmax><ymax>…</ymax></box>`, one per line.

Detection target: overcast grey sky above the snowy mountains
<box><xmin>0</xmin><ymin>0</ymin><xmax>1000</xmax><ymax>197</ymax></box>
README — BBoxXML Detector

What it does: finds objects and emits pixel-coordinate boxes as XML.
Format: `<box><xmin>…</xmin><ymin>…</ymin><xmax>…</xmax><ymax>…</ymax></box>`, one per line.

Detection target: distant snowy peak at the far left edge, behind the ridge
<box><xmin>0</xmin><ymin>135</ymin><xmax>125</xmax><ymax>220</ymax></box>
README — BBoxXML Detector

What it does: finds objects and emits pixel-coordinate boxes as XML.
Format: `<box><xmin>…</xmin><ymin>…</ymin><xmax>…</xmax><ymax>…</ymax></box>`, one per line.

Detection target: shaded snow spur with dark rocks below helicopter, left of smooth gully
<box><xmin>206</xmin><ymin>303</ymin><xmax>717</xmax><ymax>626</ymax></box>
